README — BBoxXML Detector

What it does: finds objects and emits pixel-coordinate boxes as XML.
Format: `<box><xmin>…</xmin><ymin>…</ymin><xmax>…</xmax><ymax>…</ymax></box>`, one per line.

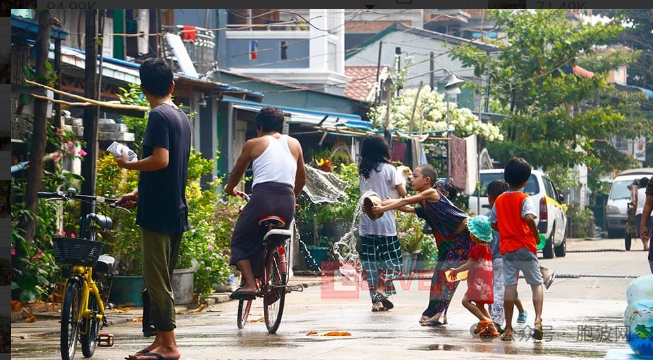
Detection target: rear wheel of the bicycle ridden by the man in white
<box><xmin>263</xmin><ymin>249</ymin><xmax>288</xmax><ymax>334</ymax></box>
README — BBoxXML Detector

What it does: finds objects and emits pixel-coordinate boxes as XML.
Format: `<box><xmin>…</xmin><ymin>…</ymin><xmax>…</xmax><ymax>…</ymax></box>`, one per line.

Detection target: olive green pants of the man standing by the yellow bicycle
<box><xmin>141</xmin><ymin>228</ymin><xmax>183</xmax><ymax>331</ymax></box>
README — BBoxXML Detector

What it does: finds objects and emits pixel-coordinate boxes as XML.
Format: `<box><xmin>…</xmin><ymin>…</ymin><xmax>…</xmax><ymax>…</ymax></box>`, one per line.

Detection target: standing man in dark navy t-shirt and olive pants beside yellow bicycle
<box><xmin>117</xmin><ymin>59</ymin><xmax>191</xmax><ymax>360</ymax></box>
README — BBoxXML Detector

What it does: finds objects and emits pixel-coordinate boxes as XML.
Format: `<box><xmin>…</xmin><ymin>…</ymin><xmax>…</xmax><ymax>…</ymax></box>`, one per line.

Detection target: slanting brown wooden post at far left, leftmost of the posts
<box><xmin>20</xmin><ymin>10</ymin><xmax>52</xmax><ymax>243</ymax></box>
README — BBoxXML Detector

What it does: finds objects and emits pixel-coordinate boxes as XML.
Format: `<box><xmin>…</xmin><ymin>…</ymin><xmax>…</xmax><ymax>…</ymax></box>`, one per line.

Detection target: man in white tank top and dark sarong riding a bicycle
<box><xmin>224</xmin><ymin>107</ymin><xmax>306</xmax><ymax>299</ymax></box>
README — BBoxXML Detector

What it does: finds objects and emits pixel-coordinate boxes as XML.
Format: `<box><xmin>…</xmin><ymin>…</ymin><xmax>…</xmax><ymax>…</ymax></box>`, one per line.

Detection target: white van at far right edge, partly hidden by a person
<box><xmin>605</xmin><ymin>168</ymin><xmax>653</xmax><ymax>238</ymax></box>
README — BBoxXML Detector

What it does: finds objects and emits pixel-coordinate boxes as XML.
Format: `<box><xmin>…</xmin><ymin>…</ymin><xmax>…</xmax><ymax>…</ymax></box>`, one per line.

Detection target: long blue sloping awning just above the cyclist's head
<box><xmin>222</xmin><ymin>96</ymin><xmax>372</xmax><ymax>130</ymax></box>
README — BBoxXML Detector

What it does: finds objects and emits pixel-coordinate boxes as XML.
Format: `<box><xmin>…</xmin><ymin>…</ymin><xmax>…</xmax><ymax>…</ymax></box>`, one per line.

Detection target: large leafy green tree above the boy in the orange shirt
<box><xmin>452</xmin><ymin>10</ymin><xmax>653</xmax><ymax>191</ymax></box>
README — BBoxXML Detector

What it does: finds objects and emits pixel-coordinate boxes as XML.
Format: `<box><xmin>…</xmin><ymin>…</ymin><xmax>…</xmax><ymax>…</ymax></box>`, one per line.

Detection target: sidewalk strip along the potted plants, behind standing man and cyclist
<box><xmin>11</xmin><ymin>276</ymin><xmax>334</xmax><ymax>341</ymax></box>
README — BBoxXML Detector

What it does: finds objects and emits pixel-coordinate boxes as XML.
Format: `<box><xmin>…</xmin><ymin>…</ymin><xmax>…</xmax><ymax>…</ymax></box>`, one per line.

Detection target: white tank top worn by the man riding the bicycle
<box><xmin>252</xmin><ymin>135</ymin><xmax>297</xmax><ymax>188</ymax></box>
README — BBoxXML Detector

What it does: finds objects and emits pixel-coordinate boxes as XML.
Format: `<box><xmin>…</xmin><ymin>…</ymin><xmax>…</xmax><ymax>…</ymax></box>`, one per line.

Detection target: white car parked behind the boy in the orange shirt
<box><xmin>468</xmin><ymin>169</ymin><xmax>567</xmax><ymax>259</ymax></box>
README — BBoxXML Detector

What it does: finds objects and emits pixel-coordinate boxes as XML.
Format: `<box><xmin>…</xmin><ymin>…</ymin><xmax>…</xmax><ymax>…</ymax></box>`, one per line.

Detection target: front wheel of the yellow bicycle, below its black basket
<box><xmin>61</xmin><ymin>277</ymin><xmax>82</xmax><ymax>360</ymax></box>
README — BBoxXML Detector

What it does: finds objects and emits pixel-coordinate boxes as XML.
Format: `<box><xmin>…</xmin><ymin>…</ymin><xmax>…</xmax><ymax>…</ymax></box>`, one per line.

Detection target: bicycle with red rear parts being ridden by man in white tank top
<box><xmin>236</xmin><ymin>194</ymin><xmax>304</xmax><ymax>334</ymax></box>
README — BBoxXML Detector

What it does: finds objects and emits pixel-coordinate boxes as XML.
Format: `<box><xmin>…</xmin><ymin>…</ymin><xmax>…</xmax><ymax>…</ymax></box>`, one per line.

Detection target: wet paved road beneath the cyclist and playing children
<box><xmin>12</xmin><ymin>240</ymin><xmax>649</xmax><ymax>360</ymax></box>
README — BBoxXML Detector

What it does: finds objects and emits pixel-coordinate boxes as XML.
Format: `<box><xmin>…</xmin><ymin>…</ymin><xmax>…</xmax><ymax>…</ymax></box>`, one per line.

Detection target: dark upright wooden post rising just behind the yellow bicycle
<box><xmin>79</xmin><ymin>10</ymin><xmax>99</xmax><ymax>219</ymax></box>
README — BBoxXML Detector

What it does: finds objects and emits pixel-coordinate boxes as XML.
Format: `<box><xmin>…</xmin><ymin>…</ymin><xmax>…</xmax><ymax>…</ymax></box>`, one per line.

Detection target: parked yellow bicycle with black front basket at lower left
<box><xmin>38</xmin><ymin>188</ymin><xmax>129</xmax><ymax>360</ymax></box>
